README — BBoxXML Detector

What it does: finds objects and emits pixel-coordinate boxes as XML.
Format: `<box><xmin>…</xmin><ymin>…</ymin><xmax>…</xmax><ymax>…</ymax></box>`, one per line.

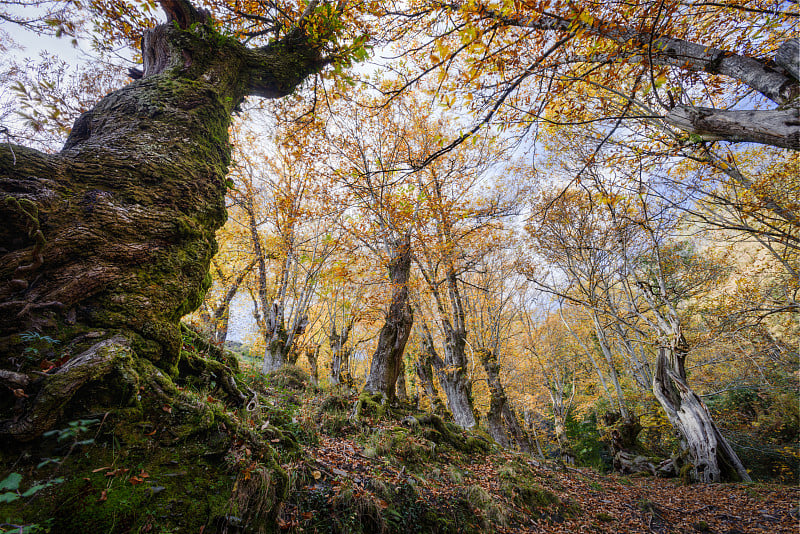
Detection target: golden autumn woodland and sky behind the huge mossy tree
<box><xmin>0</xmin><ymin>0</ymin><xmax>800</xmax><ymax>532</ymax></box>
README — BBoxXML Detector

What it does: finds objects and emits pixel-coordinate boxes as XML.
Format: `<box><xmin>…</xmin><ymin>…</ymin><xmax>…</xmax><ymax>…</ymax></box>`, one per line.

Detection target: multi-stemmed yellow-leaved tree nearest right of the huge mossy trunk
<box><xmin>231</xmin><ymin>132</ymin><xmax>337</xmax><ymax>373</ymax></box>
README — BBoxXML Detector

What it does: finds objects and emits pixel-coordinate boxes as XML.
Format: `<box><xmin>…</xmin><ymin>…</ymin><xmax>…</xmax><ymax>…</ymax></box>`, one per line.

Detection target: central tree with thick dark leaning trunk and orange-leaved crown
<box><xmin>318</xmin><ymin>98</ymin><xmax>424</xmax><ymax>401</ymax></box>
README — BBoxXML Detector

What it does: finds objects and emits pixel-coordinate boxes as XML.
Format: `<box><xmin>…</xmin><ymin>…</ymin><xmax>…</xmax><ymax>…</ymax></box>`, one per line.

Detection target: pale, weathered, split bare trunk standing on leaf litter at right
<box><xmin>653</xmin><ymin>343</ymin><xmax>750</xmax><ymax>482</ymax></box>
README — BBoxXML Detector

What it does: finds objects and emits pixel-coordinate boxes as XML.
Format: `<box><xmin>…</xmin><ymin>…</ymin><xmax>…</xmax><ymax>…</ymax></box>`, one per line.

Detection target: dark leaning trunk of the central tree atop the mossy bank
<box><xmin>364</xmin><ymin>234</ymin><xmax>414</xmax><ymax>401</ymax></box>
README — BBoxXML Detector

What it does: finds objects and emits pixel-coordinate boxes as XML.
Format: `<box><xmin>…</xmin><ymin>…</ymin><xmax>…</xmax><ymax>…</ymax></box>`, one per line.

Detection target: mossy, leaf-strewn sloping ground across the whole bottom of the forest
<box><xmin>0</xmin><ymin>352</ymin><xmax>797</xmax><ymax>534</ymax></box>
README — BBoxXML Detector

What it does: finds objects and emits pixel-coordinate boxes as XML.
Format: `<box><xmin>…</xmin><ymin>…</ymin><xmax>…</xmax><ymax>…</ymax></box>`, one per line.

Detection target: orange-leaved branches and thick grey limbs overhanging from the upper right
<box><xmin>376</xmin><ymin>0</ymin><xmax>800</xmax><ymax>163</ymax></box>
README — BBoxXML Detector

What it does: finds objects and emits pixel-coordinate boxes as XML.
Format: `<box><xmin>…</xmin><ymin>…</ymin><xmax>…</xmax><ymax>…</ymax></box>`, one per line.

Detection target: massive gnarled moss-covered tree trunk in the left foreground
<box><xmin>0</xmin><ymin>0</ymin><xmax>340</xmax><ymax>440</ymax></box>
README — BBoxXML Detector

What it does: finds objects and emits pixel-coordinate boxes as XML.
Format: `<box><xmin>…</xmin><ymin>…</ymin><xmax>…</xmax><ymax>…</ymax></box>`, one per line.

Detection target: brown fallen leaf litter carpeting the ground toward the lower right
<box><xmin>281</xmin><ymin>425</ymin><xmax>800</xmax><ymax>534</ymax></box>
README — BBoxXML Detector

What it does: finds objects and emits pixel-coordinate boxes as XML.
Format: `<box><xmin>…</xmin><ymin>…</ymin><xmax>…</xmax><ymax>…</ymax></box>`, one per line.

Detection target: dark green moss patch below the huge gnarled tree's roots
<box><xmin>0</xmin><ymin>429</ymin><xmax>238</xmax><ymax>533</ymax></box>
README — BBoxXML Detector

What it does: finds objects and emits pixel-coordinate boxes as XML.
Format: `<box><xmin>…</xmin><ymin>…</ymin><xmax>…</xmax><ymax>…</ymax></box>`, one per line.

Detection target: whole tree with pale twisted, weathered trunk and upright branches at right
<box><xmin>607</xmin><ymin>197</ymin><xmax>750</xmax><ymax>482</ymax></box>
